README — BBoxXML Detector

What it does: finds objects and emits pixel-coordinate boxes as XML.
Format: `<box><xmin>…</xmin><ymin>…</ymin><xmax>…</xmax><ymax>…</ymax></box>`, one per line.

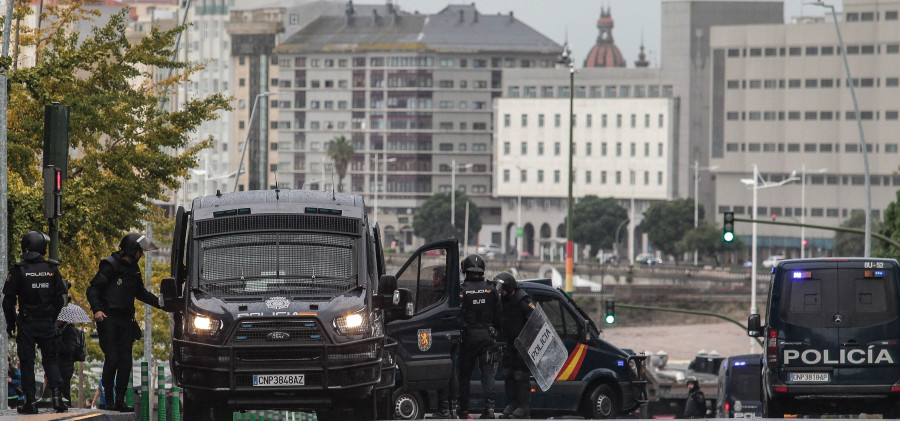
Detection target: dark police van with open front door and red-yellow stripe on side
<box><xmin>386</xmin><ymin>239</ymin><xmax>647</xmax><ymax>419</ymax></box>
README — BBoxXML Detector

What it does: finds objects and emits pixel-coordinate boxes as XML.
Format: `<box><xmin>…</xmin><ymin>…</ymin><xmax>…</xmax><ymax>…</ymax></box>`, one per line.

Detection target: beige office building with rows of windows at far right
<box><xmin>709</xmin><ymin>0</ymin><xmax>900</xmax><ymax>256</ymax></box>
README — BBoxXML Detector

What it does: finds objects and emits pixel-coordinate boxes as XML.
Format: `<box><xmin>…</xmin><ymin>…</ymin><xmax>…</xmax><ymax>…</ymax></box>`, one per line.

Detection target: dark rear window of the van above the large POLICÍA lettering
<box><xmin>780</xmin><ymin>268</ymin><xmax>897</xmax><ymax>328</ymax></box>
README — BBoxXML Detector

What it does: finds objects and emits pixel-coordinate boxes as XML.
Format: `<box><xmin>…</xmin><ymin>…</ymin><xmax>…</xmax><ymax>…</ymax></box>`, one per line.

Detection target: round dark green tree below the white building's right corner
<box><xmin>638</xmin><ymin>199</ymin><xmax>703</xmax><ymax>255</ymax></box>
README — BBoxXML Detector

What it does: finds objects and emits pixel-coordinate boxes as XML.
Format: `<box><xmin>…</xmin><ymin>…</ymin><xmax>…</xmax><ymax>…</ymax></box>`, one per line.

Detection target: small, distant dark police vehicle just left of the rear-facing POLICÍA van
<box><xmin>715</xmin><ymin>354</ymin><xmax>762</xmax><ymax>418</ymax></box>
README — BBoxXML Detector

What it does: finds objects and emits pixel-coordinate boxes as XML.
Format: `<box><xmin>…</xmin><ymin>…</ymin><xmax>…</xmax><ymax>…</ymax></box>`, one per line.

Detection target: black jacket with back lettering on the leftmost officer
<box><xmin>3</xmin><ymin>252</ymin><xmax>67</xmax><ymax>326</ymax></box>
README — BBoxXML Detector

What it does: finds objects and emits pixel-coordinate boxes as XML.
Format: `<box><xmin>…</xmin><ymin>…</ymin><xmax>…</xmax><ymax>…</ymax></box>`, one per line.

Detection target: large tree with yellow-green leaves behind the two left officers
<box><xmin>4</xmin><ymin>4</ymin><xmax>229</xmax><ymax>328</ymax></box>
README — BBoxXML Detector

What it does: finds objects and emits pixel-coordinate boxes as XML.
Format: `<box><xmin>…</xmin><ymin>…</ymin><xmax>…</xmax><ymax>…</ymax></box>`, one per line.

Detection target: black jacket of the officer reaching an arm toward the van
<box><xmin>87</xmin><ymin>251</ymin><xmax>160</xmax><ymax>317</ymax></box>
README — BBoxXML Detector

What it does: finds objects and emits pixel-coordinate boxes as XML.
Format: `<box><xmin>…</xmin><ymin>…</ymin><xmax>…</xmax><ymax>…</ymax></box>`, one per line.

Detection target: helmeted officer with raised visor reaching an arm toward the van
<box><xmin>87</xmin><ymin>233</ymin><xmax>162</xmax><ymax>412</ymax></box>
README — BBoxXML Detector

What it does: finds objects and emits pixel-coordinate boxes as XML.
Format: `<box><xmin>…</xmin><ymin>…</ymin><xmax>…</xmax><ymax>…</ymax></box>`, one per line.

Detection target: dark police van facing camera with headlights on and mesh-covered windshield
<box><xmin>160</xmin><ymin>190</ymin><xmax>408</xmax><ymax>421</ymax></box>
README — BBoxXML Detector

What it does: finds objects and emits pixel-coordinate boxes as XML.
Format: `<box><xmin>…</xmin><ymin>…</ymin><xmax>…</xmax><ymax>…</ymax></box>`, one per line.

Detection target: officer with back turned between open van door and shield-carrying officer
<box><xmin>459</xmin><ymin>254</ymin><xmax>501</xmax><ymax>418</ymax></box>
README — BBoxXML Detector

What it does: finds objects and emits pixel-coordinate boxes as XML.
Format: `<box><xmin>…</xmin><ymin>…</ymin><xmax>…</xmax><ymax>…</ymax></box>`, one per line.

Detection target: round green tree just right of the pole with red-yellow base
<box><xmin>572</xmin><ymin>195</ymin><xmax>628</xmax><ymax>252</ymax></box>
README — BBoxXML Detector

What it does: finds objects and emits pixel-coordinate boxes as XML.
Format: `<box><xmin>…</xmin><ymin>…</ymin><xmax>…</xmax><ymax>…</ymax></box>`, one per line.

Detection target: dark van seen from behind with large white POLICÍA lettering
<box><xmin>747</xmin><ymin>258</ymin><xmax>900</xmax><ymax>418</ymax></box>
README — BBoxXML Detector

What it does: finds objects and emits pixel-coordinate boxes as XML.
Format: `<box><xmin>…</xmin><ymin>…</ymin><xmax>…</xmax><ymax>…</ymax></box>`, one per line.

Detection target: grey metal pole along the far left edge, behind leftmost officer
<box><xmin>0</xmin><ymin>0</ymin><xmax>13</xmax><ymax>409</ymax></box>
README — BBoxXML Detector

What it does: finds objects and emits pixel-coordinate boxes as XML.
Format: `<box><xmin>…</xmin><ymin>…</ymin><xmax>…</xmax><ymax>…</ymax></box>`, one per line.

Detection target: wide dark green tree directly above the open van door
<box><xmin>413</xmin><ymin>191</ymin><xmax>481</xmax><ymax>241</ymax></box>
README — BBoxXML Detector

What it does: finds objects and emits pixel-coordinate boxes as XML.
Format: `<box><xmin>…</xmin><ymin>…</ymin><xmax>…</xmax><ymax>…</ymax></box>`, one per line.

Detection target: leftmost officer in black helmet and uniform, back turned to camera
<box><xmin>3</xmin><ymin>231</ymin><xmax>68</xmax><ymax>414</ymax></box>
